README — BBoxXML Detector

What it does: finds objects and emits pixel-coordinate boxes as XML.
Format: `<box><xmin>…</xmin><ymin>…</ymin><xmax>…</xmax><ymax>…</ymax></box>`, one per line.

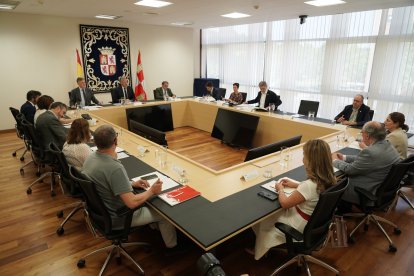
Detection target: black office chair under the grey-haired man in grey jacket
<box><xmin>344</xmin><ymin>157</ymin><xmax>414</xmax><ymax>252</ymax></box>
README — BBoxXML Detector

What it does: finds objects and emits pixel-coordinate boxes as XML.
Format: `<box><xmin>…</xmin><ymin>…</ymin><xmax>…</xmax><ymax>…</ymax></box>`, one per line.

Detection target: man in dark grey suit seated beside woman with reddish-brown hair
<box><xmin>36</xmin><ymin>102</ymin><xmax>68</xmax><ymax>149</ymax></box>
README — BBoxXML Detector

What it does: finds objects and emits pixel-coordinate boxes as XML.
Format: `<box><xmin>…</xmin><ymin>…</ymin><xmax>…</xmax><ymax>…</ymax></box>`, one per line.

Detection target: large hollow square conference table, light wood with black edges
<box><xmin>78</xmin><ymin>99</ymin><xmax>360</xmax><ymax>251</ymax></box>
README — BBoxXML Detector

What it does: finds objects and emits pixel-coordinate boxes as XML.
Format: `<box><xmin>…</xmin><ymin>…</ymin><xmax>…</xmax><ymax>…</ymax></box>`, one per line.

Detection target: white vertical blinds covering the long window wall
<box><xmin>202</xmin><ymin>4</ymin><xmax>414</xmax><ymax>128</ymax></box>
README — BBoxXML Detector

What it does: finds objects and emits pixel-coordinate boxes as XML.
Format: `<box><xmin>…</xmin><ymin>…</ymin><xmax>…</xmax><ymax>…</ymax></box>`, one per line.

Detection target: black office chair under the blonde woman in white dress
<box><xmin>271</xmin><ymin>178</ymin><xmax>348</xmax><ymax>276</ymax></box>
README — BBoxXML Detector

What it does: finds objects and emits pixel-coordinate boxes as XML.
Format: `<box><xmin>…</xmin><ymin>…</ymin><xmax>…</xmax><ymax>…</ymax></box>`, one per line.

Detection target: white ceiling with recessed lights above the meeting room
<box><xmin>4</xmin><ymin>0</ymin><xmax>414</xmax><ymax>29</ymax></box>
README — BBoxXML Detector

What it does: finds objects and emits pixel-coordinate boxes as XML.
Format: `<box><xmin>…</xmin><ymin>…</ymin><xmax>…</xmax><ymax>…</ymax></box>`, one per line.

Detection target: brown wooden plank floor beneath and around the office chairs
<box><xmin>0</xmin><ymin>132</ymin><xmax>414</xmax><ymax>276</ymax></box>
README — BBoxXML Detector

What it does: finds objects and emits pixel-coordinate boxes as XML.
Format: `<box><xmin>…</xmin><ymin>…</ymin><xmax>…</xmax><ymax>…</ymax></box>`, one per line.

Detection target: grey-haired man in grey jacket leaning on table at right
<box><xmin>332</xmin><ymin>121</ymin><xmax>400</xmax><ymax>204</ymax></box>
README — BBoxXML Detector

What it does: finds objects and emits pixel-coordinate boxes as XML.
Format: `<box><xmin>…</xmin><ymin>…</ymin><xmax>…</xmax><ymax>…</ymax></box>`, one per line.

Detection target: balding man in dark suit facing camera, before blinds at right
<box><xmin>335</xmin><ymin>95</ymin><xmax>371</xmax><ymax>126</ymax></box>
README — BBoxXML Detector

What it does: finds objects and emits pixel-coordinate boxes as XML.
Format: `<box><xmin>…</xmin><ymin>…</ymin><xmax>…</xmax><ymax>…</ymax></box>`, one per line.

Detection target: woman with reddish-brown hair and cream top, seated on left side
<box><xmin>62</xmin><ymin>118</ymin><xmax>92</xmax><ymax>170</ymax></box>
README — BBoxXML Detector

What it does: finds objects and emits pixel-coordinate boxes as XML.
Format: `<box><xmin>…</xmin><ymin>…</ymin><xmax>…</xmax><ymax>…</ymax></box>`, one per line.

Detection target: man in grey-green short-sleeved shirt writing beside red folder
<box><xmin>82</xmin><ymin>125</ymin><xmax>181</xmax><ymax>253</ymax></box>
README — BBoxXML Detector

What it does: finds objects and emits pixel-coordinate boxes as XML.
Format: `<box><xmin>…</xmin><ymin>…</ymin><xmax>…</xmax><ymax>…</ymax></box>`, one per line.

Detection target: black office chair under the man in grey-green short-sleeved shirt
<box><xmin>69</xmin><ymin>167</ymin><xmax>150</xmax><ymax>275</ymax></box>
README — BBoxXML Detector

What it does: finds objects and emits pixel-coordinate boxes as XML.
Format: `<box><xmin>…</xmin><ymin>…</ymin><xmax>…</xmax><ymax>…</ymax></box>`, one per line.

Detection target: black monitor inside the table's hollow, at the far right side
<box><xmin>211</xmin><ymin>108</ymin><xmax>260</xmax><ymax>148</ymax></box>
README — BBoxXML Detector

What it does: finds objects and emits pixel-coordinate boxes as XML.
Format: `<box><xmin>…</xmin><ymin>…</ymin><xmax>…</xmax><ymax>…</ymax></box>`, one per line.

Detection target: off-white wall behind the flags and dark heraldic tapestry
<box><xmin>0</xmin><ymin>12</ymin><xmax>200</xmax><ymax>130</ymax></box>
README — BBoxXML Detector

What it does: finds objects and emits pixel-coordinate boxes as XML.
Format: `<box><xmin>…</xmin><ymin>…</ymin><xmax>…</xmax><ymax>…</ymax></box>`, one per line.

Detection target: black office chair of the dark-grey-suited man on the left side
<box><xmin>22</xmin><ymin>120</ymin><xmax>58</xmax><ymax>196</ymax></box>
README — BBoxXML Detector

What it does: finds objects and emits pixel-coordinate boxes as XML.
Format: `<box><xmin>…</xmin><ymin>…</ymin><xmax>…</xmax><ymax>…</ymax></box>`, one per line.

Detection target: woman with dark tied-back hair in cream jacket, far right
<box><xmin>359</xmin><ymin>112</ymin><xmax>409</xmax><ymax>160</ymax></box>
